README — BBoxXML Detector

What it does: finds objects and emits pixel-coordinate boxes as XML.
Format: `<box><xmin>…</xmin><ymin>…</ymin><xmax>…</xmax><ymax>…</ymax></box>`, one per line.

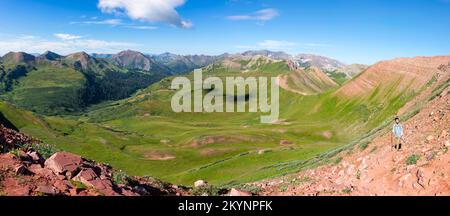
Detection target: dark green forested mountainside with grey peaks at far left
<box><xmin>0</xmin><ymin>51</ymin><xmax>168</xmax><ymax>115</ymax></box>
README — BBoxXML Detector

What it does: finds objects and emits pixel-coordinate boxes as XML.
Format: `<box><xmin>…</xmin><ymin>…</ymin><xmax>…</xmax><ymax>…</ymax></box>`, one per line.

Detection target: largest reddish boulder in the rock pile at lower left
<box><xmin>45</xmin><ymin>152</ymin><xmax>83</xmax><ymax>177</ymax></box>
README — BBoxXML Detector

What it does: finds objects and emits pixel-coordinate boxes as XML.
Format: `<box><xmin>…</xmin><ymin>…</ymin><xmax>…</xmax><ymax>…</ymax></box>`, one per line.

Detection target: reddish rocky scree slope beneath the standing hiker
<box><xmin>254</xmin><ymin>88</ymin><xmax>450</xmax><ymax>196</ymax></box>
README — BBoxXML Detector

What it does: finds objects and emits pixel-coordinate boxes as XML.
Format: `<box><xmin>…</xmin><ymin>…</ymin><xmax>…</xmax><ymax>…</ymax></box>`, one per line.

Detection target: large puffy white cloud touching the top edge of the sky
<box><xmin>98</xmin><ymin>0</ymin><xmax>193</xmax><ymax>28</ymax></box>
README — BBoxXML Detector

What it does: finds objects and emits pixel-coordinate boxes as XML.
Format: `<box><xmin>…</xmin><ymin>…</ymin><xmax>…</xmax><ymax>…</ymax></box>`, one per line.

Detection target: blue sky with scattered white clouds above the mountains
<box><xmin>0</xmin><ymin>0</ymin><xmax>450</xmax><ymax>64</ymax></box>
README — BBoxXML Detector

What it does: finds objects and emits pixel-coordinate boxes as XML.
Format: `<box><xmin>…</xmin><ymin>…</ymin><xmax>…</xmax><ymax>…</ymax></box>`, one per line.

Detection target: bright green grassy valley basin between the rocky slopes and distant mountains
<box><xmin>0</xmin><ymin>60</ymin><xmax>430</xmax><ymax>186</ymax></box>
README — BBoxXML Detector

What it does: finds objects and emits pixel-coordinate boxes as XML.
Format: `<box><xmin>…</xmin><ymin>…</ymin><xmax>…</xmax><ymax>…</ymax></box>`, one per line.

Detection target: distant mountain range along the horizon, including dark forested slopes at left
<box><xmin>0</xmin><ymin>50</ymin><xmax>363</xmax><ymax>114</ymax></box>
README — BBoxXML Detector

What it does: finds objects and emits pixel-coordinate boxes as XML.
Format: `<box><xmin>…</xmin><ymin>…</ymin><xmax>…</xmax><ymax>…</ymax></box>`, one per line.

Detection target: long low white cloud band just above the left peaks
<box><xmin>0</xmin><ymin>34</ymin><xmax>139</xmax><ymax>55</ymax></box>
